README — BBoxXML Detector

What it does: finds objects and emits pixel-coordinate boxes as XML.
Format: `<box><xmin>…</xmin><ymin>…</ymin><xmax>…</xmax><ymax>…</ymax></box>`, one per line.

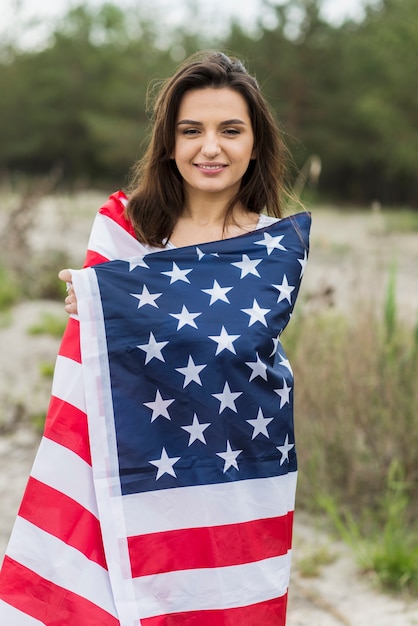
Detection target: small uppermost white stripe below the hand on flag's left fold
<box><xmin>52</xmin><ymin>355</ymin><xmax>86</xmax><ymax>413</ymax></box>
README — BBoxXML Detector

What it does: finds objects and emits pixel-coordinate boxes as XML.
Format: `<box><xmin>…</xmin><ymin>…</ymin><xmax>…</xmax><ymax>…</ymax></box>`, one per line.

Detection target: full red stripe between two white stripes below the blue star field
<box><xmin>128</xmin><ymin>512</ymin><xmax>293</xmax><ymax>578</ymax></box>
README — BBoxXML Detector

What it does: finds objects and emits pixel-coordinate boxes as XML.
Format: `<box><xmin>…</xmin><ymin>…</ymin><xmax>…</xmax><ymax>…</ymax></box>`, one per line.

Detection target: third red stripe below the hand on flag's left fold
<box><xmin>19</xmin><ymin>477</ymin><xmax>107</xmax><ymax>569</ymax></box>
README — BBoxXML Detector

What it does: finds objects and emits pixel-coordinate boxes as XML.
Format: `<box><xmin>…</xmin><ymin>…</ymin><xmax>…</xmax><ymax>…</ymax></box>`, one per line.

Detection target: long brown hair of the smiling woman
<box><xmin>126</xmin><ymin>52</ymin><xmax>288</xmax><ymax>246</ymax></box>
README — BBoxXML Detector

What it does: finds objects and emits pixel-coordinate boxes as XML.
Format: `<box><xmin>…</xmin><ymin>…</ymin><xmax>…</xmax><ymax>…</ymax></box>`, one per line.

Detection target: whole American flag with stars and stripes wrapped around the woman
<box><xmin>0</xmin><ymin>193</ymin><xmax>310</xmax><ymax>626</ymax></box>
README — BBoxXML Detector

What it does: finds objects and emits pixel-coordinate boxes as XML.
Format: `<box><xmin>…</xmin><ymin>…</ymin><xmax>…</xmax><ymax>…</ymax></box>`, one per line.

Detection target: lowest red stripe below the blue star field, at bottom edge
<box><xmin>141</xmin><ymin>594</ymin><xmax>287</xmax><ymax>626</ymax></box>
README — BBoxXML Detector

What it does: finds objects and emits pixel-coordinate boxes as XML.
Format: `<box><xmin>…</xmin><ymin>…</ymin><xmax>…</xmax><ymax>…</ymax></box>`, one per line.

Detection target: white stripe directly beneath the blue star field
<box><xmin>122</xmin><ymin>472</ymin><xmax>297</xmax><ymax>536</ymax></box>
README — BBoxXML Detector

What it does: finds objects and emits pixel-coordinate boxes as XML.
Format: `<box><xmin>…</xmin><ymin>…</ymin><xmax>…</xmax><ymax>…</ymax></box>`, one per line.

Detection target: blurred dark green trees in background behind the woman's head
<box><xmin>0</xmin><ymin>0</ymin><xmax>418</xmax><ymax>207</ymax></box>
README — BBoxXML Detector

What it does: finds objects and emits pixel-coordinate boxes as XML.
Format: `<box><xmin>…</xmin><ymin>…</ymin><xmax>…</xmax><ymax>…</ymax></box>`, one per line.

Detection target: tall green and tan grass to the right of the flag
<box><xmin>283</xmin><ymin>267</ymin><xmax>418</xmax><ymax>594</ymax></box>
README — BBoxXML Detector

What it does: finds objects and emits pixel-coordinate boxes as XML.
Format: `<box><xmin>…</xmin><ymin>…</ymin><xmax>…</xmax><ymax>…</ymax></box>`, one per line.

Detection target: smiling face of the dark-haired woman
<box><xmin>172</xmin><ymin>87</ymin><xmax>255</xmax><ymax>203</ymax></box>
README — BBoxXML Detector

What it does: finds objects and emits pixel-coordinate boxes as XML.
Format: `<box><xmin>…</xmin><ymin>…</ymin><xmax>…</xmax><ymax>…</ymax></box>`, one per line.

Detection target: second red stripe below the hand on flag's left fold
<box><xmin>44</xmin><ymin>396</ymin><xmax>91</xmax><ymax>465</ymax></box>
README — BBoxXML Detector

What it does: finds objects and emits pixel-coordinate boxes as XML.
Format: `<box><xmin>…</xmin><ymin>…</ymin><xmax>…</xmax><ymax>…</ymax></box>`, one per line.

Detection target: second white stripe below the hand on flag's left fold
<box><xmin>31</xmin><ymin>437</ymin><xmax>98</xmax><ymax>517</ymax></box>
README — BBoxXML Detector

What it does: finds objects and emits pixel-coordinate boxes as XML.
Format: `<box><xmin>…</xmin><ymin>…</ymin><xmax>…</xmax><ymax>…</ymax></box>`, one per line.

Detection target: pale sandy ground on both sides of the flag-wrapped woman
<box><xmin>0</xmin><ymin>193</ymin><xmax>418</xmax><ymax>626</ymax></box>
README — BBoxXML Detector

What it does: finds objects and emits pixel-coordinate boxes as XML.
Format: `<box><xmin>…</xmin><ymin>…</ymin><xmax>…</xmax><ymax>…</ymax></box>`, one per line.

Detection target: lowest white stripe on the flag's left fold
<box><xmin>7</xmin><ymin>517</ymin><xmax>116</xmax><ymax>616</ymax></box>
